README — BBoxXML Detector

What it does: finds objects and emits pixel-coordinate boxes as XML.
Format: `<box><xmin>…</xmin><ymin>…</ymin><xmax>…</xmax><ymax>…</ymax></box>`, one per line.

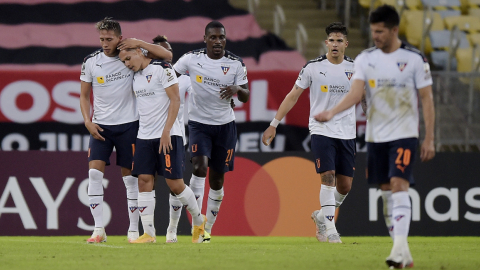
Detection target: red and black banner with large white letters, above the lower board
<box><xmin>0</xmin><ymin>71</ymin><xmax>365</xmax><ymax>152</ymax></box>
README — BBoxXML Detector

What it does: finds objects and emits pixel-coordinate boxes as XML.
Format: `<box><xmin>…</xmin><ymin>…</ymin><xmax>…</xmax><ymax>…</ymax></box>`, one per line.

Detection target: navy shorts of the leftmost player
<box><xmin>88</xmin><ymin>121</ymin><xmax>138</xmax><ymax>169</ymax></box>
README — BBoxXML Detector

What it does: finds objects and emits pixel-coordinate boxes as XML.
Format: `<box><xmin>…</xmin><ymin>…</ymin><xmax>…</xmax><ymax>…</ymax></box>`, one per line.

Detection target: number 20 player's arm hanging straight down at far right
<box><xmin>418</xmin><ymin>85</ymin><xmax>435</xmax><ymax>161</ymax></box>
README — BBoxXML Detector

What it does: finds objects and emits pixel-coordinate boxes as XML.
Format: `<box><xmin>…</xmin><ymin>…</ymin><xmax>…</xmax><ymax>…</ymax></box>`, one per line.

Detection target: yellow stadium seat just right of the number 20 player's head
<box><xmin>404</xmin><ymin>10</ymin><xmax>444</xmax><ymax>54</ymax></box>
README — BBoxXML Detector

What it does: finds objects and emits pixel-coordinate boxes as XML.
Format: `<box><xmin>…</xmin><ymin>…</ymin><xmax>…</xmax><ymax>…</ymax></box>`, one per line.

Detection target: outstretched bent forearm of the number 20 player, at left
<box><xmin>314</xmin><ymin>80</ymin><xmax>365</xmax><ymax>122</ymax></box>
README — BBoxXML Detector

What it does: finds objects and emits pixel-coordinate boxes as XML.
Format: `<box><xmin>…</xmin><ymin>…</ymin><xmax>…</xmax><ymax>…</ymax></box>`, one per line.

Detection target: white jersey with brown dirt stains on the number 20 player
<box><xmin>353</xmin><ymin>43</ymin><xmax>432</xmax><ymax>142</ymax></box>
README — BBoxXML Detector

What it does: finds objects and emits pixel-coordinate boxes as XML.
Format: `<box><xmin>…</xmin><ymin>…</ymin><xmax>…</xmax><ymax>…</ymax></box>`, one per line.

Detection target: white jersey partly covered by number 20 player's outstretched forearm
<box><xmin>295</xmin><ymin>55</ymin><xmax>356</xmax><ymax>140</ymax></box>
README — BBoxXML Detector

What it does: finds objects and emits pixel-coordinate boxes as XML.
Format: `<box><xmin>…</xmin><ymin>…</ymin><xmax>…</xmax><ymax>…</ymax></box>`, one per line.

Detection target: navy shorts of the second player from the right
<box><xmin>312</xmin><ymin>134</ymin><xmax>356</xmax><ymax>177</ymax></box>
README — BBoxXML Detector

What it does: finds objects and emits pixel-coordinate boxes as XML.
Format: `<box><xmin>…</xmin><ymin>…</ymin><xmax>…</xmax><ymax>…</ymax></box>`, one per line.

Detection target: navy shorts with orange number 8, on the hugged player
<box><xmin>132</xmin><ymin>136</ymin><xmax>185</xmax><ymax>179</ymax></box>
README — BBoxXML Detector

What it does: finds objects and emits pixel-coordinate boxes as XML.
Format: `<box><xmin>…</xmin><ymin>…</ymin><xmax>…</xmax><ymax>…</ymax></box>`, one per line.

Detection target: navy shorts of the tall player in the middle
<box><xmin>188</xmin><ymin>121</ymin><xmax>237</xmax><ymax>173</ymax></box>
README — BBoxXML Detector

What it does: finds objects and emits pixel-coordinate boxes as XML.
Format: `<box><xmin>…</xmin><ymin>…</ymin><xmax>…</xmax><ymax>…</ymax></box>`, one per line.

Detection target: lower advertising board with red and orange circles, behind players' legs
<box><xmin>0</xmin><ymin>151</ymin><xmax>480</xmax><ymax>236</ymax></box>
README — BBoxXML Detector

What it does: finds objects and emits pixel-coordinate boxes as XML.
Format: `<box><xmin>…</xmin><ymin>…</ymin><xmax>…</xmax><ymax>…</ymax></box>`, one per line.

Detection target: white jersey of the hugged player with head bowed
<box><xmin>133</xmin><ymin>60</ymin><xmax>182</xmax><ymax>140</ymax></box>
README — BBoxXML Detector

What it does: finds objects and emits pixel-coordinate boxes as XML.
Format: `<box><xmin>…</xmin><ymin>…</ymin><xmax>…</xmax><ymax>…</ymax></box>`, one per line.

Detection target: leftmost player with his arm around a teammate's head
<box><xmin>80</xmin><ymin>17</ymin><xmax>172</xmax><ymax>243</ymax></box>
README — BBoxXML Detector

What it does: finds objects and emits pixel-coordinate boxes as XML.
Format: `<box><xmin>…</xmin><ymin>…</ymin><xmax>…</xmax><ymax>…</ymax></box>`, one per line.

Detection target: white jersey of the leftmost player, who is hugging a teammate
<box><xmin>80</xmin><ymin>49</ymin><xmax>138</xmax><ymax>125</ymax></box>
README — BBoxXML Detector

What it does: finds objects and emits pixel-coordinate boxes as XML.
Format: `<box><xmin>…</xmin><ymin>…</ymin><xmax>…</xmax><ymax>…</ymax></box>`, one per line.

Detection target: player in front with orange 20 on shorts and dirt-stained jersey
<box><xmin>315</xmin><ymin>5</ymin><xmax>435</xmax><ymax>268</ymax></box>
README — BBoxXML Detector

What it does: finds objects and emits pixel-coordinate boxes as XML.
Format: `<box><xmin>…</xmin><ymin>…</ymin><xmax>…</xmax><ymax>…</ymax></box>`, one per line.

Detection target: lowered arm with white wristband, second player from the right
<box><xmin>262</xmin><ymin>84</ymin><xmax>305</xmax><ymax>145</ymax></box>
